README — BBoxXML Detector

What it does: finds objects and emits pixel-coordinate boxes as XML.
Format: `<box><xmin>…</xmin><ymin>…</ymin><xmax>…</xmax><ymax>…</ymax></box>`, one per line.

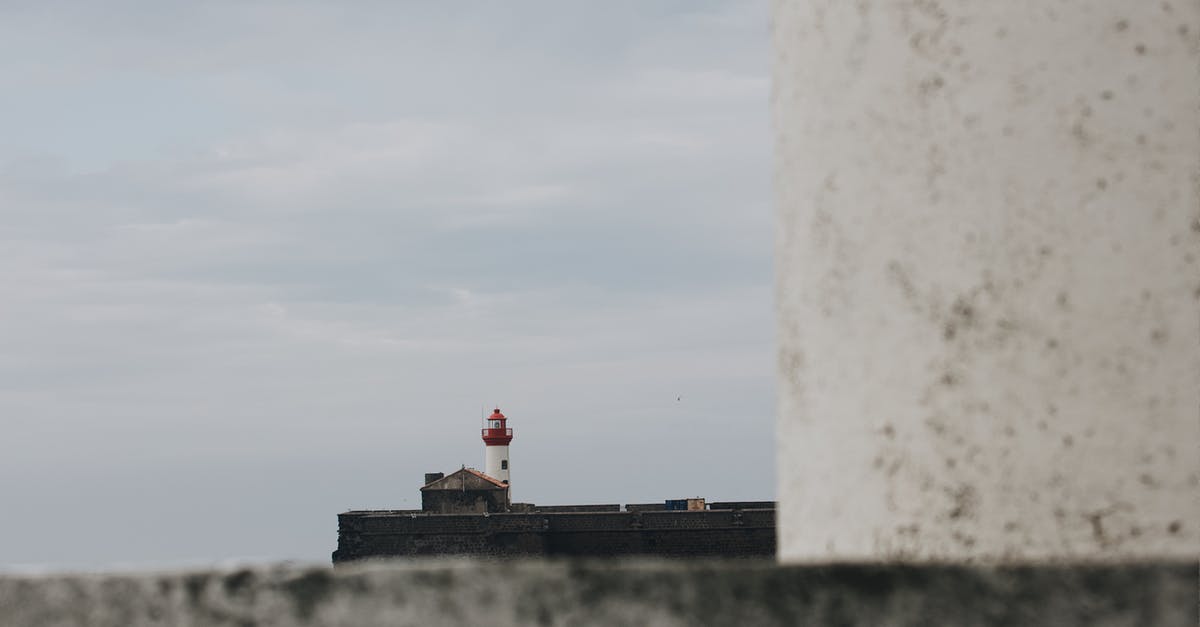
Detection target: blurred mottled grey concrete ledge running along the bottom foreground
<box><xmin>0</xmin><ymin>561</ymin><xmax>1198</xmax><ymax>627</ymax></box>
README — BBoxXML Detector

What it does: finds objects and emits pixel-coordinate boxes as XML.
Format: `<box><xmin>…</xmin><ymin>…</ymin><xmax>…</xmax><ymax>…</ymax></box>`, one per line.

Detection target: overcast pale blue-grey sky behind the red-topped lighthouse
<box><xmin>0</xmin><ymin>0</ymin><xmax>774</xmax><ymax>571</ymax></box>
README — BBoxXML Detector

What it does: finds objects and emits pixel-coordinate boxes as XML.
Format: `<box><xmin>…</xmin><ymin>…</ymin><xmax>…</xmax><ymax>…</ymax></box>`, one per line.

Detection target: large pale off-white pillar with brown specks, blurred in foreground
<box><xmin>772</xmin><ymin>0</ymin><xmax>1200</xmax><ymax>562</ymax></box>
